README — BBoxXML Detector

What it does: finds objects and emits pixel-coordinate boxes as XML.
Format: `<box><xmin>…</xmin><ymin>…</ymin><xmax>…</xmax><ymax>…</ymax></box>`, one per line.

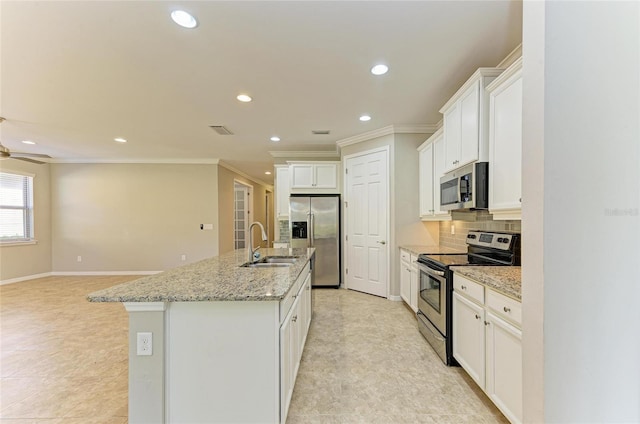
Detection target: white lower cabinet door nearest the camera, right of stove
<box><xmin>486</xmin><ymin>312</ymin><xmax>522</xmax><ymax>423</ymax></box>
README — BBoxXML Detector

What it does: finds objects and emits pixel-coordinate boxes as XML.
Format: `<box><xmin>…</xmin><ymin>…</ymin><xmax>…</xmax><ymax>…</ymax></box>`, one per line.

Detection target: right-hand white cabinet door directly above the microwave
<box><xmin>456</xmin><ymin>81</ymin><xmax>480</xmax><ymax>167</ymax></box>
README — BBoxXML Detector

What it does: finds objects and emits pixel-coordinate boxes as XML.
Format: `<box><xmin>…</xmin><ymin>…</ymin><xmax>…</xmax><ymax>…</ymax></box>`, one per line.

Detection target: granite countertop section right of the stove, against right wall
<box><xmin>452</xmin><ymin>266</ymin><xmax>522</xmax><ymax>302</ymax></box>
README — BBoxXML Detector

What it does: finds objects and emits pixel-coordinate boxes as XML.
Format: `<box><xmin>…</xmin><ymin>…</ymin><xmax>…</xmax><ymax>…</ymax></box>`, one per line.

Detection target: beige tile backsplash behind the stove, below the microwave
<box><xmin>440</xmin><ymin>211</ymin><xmax>521</xmax><ymax>251</ymax></box>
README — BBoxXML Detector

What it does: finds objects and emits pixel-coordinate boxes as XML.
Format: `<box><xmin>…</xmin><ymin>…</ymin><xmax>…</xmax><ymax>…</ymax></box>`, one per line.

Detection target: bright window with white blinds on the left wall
<box><xmin>0</xmin><ymin>172</ymin><xmax>33</xmax><ymax>243</ymax></box>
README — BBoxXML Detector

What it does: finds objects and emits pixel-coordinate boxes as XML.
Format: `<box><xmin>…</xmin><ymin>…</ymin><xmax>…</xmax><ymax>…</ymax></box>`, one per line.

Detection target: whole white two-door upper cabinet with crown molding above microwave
<box><xmin>440</xmin><ymin>68</ymin><xmax>503</xmax><ymax>172</ymax></box>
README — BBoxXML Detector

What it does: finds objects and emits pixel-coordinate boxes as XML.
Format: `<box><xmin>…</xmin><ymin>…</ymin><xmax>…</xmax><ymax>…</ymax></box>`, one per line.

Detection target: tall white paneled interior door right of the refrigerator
<box><xmin>345</xmin><ymin>150</ymin><xmax>389</xmax><ymax>297</ymax></box>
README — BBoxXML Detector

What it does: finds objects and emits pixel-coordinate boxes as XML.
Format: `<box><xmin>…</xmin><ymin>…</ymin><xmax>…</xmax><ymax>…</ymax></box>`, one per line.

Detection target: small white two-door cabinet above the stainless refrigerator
<box><xmin>289</xmin><ymin>162</ymin><xmax>339</xmax><ymax>193</ymax></box>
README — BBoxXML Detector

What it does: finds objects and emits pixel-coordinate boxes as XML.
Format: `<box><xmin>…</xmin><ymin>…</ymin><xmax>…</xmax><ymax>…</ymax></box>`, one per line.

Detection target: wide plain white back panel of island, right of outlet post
<box><xmin>166</xmin><ymin>301</ymin><xmax>280</xmax><ymax>423</ymax></box>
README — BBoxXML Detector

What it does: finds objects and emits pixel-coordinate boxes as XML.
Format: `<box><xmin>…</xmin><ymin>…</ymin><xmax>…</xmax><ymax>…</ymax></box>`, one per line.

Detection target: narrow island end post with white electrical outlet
<box><xmin>124</xmin><ymin>302</ymin><xmax>166</xmax><ymax>424</ymax></box>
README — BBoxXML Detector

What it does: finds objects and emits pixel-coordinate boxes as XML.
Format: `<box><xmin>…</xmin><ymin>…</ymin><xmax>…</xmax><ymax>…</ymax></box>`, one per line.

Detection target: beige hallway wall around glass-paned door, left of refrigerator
<box><xmin>218</xmin><ymin>166</ymin><xmax>274</xmax><ymax>253</ymax></box>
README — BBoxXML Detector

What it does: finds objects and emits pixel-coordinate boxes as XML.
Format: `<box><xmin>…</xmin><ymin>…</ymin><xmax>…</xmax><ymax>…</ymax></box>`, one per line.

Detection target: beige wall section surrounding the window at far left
<box><xmin>0</xmin><ymin>160</ymin><xmax>51</xmax><ymax>282</ymax></box>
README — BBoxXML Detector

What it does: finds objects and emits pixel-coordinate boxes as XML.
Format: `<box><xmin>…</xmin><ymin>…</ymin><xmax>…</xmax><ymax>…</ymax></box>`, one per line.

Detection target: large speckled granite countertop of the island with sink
<box><xmin>87</xmin><ymin>248</ymin><xmax>315</xmax><ymax>302</ymax></box>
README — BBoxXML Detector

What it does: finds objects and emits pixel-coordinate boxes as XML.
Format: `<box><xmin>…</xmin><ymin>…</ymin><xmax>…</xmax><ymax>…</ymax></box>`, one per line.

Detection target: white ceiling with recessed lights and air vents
<box><xmin>0</xmin><ymin>0</ymin><xmax>522</xmax><ymax>182</ymax></box>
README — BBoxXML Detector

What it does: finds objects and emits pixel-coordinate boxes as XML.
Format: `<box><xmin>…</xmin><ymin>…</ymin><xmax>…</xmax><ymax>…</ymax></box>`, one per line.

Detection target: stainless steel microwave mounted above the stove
<box><xmin>440</xmin><ymin>162</ymin><xmax>489</xmax><ymax>211</ymax></box>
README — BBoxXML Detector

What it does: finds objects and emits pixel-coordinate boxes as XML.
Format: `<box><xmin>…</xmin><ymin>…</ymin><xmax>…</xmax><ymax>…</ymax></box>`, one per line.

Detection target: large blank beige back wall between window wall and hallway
<box><xmin>51</xmin><ymin>164</ymin><xmax>218</xmax><ymax>272</ymax></box>
